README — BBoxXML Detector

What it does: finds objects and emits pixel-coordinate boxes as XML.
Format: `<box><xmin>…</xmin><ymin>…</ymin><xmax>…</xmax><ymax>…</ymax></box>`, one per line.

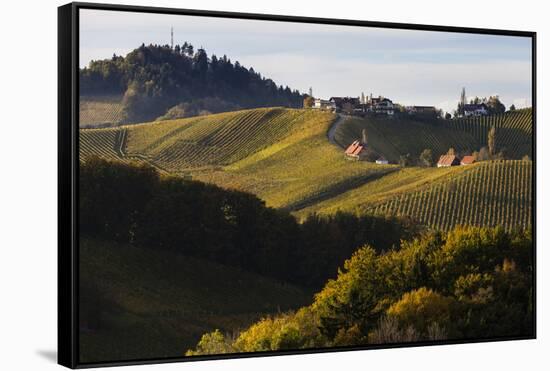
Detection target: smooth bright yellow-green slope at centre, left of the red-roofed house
<box><xmin>193</xmin><ymin>110</ymin><xmax>397</xmax><ymax>211</ymax></box>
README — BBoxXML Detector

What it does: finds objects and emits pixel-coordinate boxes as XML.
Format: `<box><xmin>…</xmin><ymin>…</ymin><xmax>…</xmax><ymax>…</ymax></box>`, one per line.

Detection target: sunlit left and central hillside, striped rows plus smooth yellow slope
<box><xmin>80</xmin><ymin>108</ymin><xmax>397</xmax><ymax>209</ymax></box>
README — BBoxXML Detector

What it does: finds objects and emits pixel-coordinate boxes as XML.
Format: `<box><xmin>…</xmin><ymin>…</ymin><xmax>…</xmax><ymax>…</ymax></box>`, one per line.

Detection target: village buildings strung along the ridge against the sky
<box><xmin>312</xmin><ymin>94</ymin><xmax>489</xmax><ymax>117</ymax></box>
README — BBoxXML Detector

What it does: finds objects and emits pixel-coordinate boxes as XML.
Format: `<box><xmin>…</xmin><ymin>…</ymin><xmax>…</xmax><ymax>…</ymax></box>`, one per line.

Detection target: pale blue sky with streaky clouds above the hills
<box><xmin>80</xmin><ymin>9</ymin><xmax>531</xmax><ymax>112</ymax></box>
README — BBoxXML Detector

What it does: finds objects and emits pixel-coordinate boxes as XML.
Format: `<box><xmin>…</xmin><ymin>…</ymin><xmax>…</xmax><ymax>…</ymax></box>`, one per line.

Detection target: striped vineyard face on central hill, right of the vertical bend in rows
<box><xmin>126</xmin><ymin>108</ymin><xmax>330</xmax><ymax>172</ymax></box>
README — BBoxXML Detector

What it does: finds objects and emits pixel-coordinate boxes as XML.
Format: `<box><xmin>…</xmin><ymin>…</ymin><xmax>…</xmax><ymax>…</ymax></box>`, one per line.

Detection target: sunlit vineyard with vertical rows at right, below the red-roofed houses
<box><xmin>367</xmin><ymin>161</ymin><xmax>533</xmax><ymax>230</ymax></box>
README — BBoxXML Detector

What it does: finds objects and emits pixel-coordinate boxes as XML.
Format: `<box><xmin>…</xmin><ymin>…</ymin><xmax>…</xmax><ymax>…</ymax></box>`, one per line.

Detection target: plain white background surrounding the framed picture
<box><xmin>0</xmin><ymin>0</ymin><xmax>550</xmax><ymax>371</ymax></box>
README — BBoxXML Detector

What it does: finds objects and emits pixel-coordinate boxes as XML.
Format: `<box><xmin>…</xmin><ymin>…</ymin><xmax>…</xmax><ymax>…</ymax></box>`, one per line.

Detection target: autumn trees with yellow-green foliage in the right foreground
<box><xmin>187</xmin><ymin>227</ymin><xmax>533</xmax><ymax>355</ymax></box>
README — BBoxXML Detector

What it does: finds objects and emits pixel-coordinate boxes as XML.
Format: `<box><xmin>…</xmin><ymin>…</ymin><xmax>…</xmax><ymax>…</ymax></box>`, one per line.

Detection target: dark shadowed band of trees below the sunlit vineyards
<box><xmin>79</xmin><ymin>158</ymin><xmax>418</xmax><ymax>288</ymax></box>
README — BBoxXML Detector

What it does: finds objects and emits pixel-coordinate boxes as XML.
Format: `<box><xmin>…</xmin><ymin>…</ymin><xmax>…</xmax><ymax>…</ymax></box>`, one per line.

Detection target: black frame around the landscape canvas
<box><xmin>58</xmin><ymin>2</ymin><xmax>537</xmax><ymax>368</ymax></box>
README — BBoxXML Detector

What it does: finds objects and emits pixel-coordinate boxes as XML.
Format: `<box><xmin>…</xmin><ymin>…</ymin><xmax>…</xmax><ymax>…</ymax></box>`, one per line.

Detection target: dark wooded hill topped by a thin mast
<box><xmin>80</xmin><ymin>42</ymin><xmax>303</xmax><ymax>122</ymax></box>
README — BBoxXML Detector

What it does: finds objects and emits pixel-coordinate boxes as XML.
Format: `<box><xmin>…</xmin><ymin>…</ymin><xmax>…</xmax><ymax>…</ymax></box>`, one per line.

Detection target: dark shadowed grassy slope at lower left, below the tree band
<box><xmin>80</xmin><ymin>239</ymin><xmax>310</xmax><ymax>362</ymax></box>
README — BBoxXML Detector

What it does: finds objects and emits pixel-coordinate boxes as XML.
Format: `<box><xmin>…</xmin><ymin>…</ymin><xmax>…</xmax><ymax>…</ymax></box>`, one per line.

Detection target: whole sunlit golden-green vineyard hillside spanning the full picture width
<box><xmin>81</xmin><ymin>108</ymin><xmax>531</xmax><ymax>229</ymax></box>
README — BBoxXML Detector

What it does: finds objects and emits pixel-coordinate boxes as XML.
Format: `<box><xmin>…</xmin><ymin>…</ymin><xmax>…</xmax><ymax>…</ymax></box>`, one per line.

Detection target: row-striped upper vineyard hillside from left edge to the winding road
<box><xmin>80</xmin><ymin>108</ymin><xmax>330</xmax><ymax>173</ymax></box>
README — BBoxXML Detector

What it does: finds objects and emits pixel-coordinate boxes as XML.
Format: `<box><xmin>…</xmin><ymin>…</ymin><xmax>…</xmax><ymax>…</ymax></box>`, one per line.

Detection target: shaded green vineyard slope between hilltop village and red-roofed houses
<box><xmin>335</xmin><ymin>109</ymin><xmax>532</xmax><ymax>162</ymax></box>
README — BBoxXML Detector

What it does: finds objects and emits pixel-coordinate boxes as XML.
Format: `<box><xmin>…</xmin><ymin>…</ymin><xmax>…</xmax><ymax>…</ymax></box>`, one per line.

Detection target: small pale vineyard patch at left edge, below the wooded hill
<box><xmin>79</xmin><ymin>96</ymin><xmax>124</xmax><ymax>127</ymax></box>
